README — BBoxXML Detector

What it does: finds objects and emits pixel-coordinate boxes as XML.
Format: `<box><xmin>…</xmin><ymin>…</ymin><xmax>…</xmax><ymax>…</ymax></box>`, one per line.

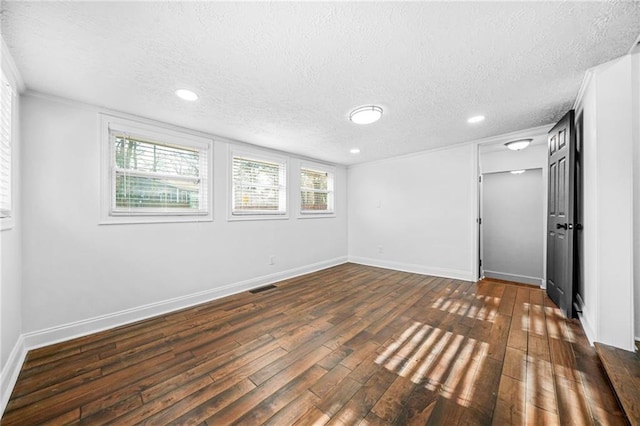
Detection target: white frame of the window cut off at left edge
<box><xmin>0</xmin><ymin>69</ymin><xmax>17</xmax><ymax>231</ymax></box>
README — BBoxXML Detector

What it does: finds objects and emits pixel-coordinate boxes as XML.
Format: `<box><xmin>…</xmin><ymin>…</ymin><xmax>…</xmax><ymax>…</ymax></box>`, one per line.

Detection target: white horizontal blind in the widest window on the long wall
<box><xmin>110</xmin><ymin>130</ymin><xmax>208</xmax><ymax>215</ymax></box>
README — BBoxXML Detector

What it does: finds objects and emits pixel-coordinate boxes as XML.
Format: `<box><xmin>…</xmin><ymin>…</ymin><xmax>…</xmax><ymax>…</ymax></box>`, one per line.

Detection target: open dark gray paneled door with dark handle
<box><xmin>547</xmin><ymin>111</ymin><xmax>576</xmax><ymax>318</ymax></box>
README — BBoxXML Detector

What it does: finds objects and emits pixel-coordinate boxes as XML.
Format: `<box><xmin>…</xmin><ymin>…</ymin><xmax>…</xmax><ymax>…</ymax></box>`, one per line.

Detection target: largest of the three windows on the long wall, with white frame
<box><xmin>103</xmin><ymin>117</ymin><xmax>211</xmax><ymax>222</ymax></box>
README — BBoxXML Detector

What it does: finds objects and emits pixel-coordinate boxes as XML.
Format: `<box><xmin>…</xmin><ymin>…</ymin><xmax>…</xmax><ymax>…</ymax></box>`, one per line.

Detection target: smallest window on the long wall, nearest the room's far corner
<box><xmin>300</xmin><ymin>164</ymin><xmax>335</xmax><ymax>215</ymax></box>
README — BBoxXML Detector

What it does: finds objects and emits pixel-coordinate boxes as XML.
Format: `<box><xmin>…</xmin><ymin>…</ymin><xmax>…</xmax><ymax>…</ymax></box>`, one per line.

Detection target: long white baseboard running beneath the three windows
<box><xmin>24</xmin><ymin>256</ymin><xmax>347</xmax><ymax>350</ymax></box>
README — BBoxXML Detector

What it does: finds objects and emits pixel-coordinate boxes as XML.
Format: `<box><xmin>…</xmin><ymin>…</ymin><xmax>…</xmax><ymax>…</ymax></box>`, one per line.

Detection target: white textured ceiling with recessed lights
<box><xmin>2</xmin><ymin>0</ymin><xmax>640</xmax><ymax>164</ymax></box>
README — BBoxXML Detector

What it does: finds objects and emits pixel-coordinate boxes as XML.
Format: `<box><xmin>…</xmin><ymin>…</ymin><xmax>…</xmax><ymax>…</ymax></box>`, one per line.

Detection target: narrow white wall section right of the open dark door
<box><xmin>577</xmin><ymin>56</ymin><xmax>640</xmax><ymax>350</ymax></box>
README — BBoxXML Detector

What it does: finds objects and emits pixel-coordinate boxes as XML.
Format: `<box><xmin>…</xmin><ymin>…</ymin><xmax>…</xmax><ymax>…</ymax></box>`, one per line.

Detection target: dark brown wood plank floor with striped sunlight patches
<box><xmin>2</xmin><ymin>264</ymin><xmax>625</xmax><ymax>425</ymax></box>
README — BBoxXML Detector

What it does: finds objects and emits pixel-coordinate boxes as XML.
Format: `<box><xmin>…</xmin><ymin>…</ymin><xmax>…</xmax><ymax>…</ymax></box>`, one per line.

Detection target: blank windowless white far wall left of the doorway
<box><xmin>348</xmin><ymin>144</ymin><xmax>477</xmax><ymax>280</ymax></box>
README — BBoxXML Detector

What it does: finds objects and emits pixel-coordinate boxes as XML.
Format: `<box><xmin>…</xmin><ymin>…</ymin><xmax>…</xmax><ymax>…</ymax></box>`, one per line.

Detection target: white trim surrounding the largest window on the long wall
<box><xmin>99</xmin><ymin>114</ymin><xmax>213</xmax><ymax>225</ymax></box>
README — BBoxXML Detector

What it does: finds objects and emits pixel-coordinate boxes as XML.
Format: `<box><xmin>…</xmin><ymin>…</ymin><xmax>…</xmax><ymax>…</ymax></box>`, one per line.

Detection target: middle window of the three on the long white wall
<box><xmin>231</xmin><ymin>152</ymin><xmax>287</xmax><ymax>216</ymax></box>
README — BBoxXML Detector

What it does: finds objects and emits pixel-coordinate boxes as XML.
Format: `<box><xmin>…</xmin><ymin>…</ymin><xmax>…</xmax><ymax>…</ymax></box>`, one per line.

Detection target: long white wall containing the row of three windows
<box><xmin>22</xmin><ymin>94</ymin><xmax>347</xmax><ymax>345</ymax></box>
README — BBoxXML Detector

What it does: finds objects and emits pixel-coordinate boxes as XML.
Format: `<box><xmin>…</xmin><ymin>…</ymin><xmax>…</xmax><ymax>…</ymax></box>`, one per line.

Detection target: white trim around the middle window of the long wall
<box><xmin>227</xmin><ymin>146</ymin><xmax>291</xmax><ymax>221</ymax></box>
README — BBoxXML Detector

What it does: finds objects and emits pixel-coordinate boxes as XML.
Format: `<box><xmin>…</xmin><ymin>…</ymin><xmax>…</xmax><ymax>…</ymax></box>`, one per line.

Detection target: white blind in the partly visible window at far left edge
<box><xmin>0</xmin><ymin>72</ymin><xmax>14</xmax><ymax>218</ymax></box>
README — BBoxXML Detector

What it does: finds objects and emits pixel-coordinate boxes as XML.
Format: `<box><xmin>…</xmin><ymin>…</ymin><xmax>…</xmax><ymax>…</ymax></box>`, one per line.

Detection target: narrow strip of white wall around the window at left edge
<box><xmin>0</xmin><ymin>39</ymin><xmax>23</xmax><ymax>413</ymax></box>
